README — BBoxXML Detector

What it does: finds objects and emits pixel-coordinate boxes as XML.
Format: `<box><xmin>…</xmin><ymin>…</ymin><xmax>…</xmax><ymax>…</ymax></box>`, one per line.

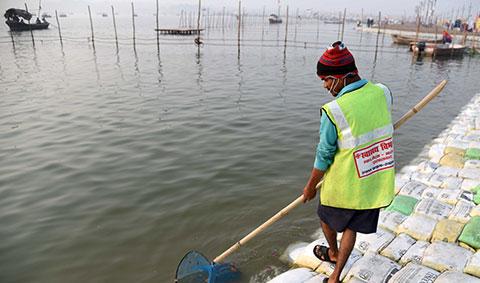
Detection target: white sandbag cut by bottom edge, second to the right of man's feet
<box><xmin>388</xmin><ymin>263</ymin><xmax>440</xmax><ymax>283</ymax></box>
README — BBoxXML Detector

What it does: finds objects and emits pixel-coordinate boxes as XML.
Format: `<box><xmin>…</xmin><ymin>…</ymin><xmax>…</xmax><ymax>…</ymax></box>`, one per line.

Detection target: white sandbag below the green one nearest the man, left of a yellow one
<box><xmin>398</xmin><ymin>214</ymin><xmax>437</xmax><ymax>241</ymax></box>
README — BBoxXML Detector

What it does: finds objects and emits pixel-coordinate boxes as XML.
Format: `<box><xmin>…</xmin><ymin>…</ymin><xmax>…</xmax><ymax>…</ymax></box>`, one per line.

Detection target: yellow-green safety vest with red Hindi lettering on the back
<box><xmin>320</xmin><ymin>82</ymin><xmax>395</xmax><ymax>210</ymax></box>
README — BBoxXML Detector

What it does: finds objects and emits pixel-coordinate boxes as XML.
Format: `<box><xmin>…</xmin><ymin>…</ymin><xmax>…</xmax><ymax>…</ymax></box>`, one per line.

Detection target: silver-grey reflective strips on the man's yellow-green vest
<box><xmin>329</xmin><ymin>87</ymin><xmax>393</xmax><ymax>149</ymax></box>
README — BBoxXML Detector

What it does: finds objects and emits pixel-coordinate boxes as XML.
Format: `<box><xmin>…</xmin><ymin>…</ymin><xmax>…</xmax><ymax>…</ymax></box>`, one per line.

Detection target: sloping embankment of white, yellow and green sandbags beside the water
<box><xmin>269</xmin><ymin>94</ymin><xmax>480</xmax><ymax>283</ymax></box>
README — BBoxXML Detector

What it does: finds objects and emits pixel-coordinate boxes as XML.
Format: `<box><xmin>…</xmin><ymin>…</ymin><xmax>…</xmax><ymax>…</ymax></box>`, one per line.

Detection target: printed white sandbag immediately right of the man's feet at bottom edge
<box><xmin>346</xmin><ymin>252</ymin><xmax>400</xmax><ymax>283</ymax></box>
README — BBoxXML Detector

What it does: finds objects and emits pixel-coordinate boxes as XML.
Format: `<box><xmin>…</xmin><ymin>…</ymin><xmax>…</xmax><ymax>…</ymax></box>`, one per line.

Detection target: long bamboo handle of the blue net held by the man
<box><xmin>213</xmin><ymin>79</ymin><xmax>447</xmax><ymax>263</ymax></box>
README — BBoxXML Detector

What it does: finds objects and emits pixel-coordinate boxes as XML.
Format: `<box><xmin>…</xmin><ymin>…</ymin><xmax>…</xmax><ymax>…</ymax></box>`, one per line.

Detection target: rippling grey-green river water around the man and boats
<box><xmin>0</xmin><ymin>10</ymin><xmax>480</xmax><ymax>282</ymax></box>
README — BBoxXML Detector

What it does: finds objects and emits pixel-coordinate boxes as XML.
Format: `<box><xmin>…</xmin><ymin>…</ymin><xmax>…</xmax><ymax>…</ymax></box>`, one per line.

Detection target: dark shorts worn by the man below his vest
<box><xmin>317</xmin><ymin>204</ymin><xmax>380</xmax><ymax>234</ymax></box>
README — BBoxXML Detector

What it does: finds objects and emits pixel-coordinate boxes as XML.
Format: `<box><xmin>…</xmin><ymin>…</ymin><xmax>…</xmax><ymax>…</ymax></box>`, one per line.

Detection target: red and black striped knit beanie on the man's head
<box><xmin>317</xmin><ymin>41</ymin><xmax>358</xmax><ymax>79</ymax></box>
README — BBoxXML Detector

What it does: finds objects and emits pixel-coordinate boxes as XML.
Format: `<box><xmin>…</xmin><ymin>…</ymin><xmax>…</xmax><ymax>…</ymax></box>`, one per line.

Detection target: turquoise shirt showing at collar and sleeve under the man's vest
<box><xmin>313</xmin><ymin>80</ymin><xmax>392</xmax><ymax>171</ymax></box>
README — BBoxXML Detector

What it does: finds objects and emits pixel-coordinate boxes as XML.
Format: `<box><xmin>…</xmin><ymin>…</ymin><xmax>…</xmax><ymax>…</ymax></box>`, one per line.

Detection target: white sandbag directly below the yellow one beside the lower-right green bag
<box><xmin>422</xmin><ymin>242</ymin><xmax>473</xmax><ymax>272</ymax></box>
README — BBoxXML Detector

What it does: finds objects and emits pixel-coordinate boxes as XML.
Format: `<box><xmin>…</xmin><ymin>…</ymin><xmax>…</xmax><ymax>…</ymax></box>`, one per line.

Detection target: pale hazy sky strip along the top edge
<box><xmin>0</xmin><ymin>0</ymin><xmax>480</xmax><ymax>16</ymax></box>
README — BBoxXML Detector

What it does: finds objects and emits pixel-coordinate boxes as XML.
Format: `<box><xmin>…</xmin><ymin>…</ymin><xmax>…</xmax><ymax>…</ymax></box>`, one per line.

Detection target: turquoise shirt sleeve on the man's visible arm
<box><xmin>313</xmin><ymin>109</ymin><xmax>338</xmax><ymax>171</ymax></box>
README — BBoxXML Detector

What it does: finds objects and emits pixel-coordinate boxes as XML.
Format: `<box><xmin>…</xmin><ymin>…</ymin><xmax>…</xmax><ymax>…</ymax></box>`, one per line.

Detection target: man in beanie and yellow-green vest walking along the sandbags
<box><xmin>303</xmin><ymin>41</ymin><xmax>395</xmax><ymax>282</ymax></box>
